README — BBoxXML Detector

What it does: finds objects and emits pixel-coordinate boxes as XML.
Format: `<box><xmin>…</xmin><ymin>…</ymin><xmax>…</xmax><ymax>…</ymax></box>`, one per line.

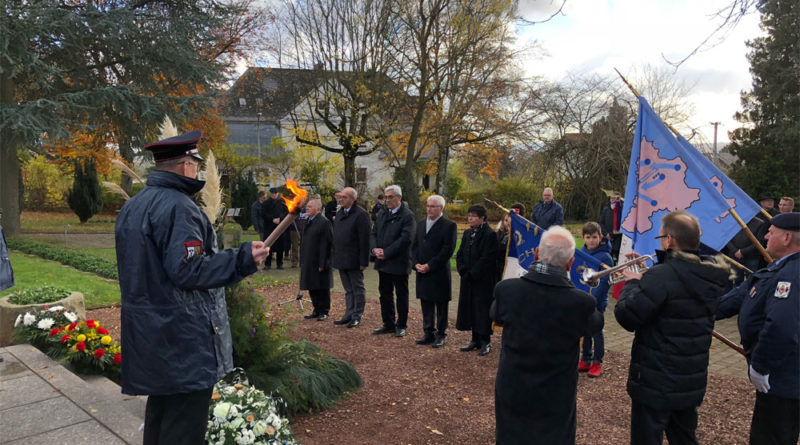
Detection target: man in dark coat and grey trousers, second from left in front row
<box><xmin>333</xmin><ymin>187</ymin><xmax>370</xmax><ymax>328</ymax></box>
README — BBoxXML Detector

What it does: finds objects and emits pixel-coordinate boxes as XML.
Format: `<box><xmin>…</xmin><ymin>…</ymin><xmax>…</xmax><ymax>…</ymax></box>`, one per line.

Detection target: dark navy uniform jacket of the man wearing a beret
<box><xmin>717</xmin><ymin>253</ymin><xmax>800</xmax><ymax>399</ymax></box>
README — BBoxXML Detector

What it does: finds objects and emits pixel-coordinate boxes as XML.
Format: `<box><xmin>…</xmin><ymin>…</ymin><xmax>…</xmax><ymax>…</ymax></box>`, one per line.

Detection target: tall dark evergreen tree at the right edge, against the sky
<box><xmin>730</xmin><ymin>0</ymin><xmax>800</xmax><ymax>197</ymax></box>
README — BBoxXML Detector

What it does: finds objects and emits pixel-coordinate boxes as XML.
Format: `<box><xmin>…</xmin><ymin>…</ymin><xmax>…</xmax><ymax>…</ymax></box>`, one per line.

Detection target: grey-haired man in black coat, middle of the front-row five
<box><xmin>369</xmin><ymin>185</ymin><xmax>415</xmax><ymax>337</ymax></box>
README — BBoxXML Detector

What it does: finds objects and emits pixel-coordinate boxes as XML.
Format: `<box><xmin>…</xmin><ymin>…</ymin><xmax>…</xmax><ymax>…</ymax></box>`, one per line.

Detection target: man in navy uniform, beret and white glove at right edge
<box><xmin>717</xmin><ymin>212</ymin><xmax>800</xmax><ymax>445</ymax></box>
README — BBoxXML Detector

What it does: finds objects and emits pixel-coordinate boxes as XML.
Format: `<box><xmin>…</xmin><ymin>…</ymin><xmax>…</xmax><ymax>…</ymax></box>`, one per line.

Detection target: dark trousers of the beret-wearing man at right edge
<box><xmin>750</xmin><ymin>392</ymin><xmax>800</xmax><ymax>445</ymax></box>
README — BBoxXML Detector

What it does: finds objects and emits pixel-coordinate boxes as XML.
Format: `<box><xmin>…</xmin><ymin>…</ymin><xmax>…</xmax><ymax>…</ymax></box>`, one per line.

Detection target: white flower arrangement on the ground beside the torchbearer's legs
<box><xmin>206</xmin><ymin>379</ymin><xmax>297</xmax><ymax>445</ymax></box>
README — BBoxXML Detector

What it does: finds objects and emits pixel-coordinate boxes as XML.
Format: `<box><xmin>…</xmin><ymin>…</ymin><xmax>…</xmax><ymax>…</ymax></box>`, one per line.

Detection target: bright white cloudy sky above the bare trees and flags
<box><xmin>518</xmin><ymin>0</ymin><xmax>762</xmax><ymax>143</ymax></box>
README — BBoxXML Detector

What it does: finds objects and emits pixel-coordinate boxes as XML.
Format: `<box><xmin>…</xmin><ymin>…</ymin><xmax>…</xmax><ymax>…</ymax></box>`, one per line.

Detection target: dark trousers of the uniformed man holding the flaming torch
<box><xmin>143</xmin><ymin>388</ymin><xmax>214</xmax><ymax>445</ymax></box>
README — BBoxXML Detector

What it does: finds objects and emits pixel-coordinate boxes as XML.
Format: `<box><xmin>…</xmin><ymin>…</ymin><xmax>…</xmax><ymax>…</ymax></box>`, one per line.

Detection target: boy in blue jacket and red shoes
<box><xmin>578</xmin><ymin>221</ymin><xmax>614</xmax><ymax>378</ymax></box>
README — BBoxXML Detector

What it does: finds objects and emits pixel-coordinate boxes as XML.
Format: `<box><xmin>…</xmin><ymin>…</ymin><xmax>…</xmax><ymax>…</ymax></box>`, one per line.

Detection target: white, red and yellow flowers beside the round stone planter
<box><xmin>14</xmin><ymin>306</ymin><xmax>122</xmax><ymax>377</ymax></box>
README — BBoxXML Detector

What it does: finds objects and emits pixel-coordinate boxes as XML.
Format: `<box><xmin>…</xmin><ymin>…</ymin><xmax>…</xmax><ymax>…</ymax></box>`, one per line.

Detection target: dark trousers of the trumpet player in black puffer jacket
<box><xmin>631</xmin><ymin>400</ymin><xmax>697</xmax><ymax>445</ymax></box>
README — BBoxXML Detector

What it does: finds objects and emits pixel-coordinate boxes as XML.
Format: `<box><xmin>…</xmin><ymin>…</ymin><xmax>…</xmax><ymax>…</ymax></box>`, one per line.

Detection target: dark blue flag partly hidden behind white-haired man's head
<box><xmin>503</xmin><ymin>212</ymin><xmax>600</xmax><ymax>292</ymax></box>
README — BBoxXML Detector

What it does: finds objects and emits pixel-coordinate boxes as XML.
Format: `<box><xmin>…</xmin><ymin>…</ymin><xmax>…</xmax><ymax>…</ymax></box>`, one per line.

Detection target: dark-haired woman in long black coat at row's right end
<box><xmin>456</xmin><ymin>205</ymin><xmax>497</xmax><ymax>355</ymax></box>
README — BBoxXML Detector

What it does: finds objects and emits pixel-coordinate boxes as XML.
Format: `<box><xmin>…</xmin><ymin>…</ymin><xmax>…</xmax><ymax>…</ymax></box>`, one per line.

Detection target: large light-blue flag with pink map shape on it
<box><xmin>620</xmin><ymin>97</ymin><xmax>754</xmax><ymax>261</ymax></box>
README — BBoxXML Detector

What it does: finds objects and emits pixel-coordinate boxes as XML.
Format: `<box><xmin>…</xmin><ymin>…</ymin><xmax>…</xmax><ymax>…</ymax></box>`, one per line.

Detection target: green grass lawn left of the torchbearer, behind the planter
<box><xmin>0</xmin><ymin>251</ymin><xmax>120</xmax><ymax>309</ymax></box>
